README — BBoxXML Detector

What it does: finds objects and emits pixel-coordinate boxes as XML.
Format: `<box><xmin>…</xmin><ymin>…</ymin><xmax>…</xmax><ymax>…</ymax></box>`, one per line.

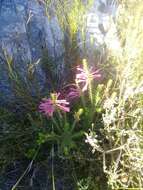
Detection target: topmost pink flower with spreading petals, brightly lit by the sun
<box><xmin>75</xmin><ymin>67</ymin><xmax>101</xmax><ymax>92</ymax></box>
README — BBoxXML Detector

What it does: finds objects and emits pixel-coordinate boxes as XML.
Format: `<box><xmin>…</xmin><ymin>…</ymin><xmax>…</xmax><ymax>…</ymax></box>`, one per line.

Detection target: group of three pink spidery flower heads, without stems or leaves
<box><xmin>39</xmin><ymin>62</ymin><xmax>101</xmax><ymax>117</ymax></box>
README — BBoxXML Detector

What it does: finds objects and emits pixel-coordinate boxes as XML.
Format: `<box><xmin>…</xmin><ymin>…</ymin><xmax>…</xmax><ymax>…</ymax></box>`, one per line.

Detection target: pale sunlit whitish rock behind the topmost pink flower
<box><xmin>78</xmin><ymin>0</ymin><xmax>118</xmax><ymax>64</ymax></box>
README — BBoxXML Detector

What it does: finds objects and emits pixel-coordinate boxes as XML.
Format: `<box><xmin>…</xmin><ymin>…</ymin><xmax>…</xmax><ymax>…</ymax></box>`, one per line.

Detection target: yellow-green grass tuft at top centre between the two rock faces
<box><xmin>45</xmin><ymin>0</ymin><xmax>93</xmax><ymax>37</ymax></box>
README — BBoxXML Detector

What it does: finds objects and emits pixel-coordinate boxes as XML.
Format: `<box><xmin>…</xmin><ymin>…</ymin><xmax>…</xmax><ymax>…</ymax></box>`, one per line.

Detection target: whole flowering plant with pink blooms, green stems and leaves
<box><xmin>39</xmin><ymin>60</ymin><xmax>101</xmax><ymax>154</ymax></box>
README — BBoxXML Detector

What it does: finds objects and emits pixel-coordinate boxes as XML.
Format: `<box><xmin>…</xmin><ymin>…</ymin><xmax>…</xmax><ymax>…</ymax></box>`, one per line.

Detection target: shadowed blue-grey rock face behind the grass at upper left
<box><xmin>0</xmin><ymin>0</ymin><xmax>64</xmax><ymax>104</ymax></box>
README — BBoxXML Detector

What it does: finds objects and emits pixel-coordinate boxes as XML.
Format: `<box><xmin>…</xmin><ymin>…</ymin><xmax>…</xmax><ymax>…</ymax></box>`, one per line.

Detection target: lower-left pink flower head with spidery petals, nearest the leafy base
<box><xmin>39</xmin><ymin>93</ymin><xmax>70</xmax><ymax>117</ymax></box>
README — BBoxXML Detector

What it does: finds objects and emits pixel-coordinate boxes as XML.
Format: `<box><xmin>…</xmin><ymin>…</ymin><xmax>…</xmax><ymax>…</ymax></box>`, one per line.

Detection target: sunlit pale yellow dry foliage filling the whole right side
<box><xmin>86</xmin><ymin>0</ymin><xmax>143</xmax><ymax>190</ymax></box>
